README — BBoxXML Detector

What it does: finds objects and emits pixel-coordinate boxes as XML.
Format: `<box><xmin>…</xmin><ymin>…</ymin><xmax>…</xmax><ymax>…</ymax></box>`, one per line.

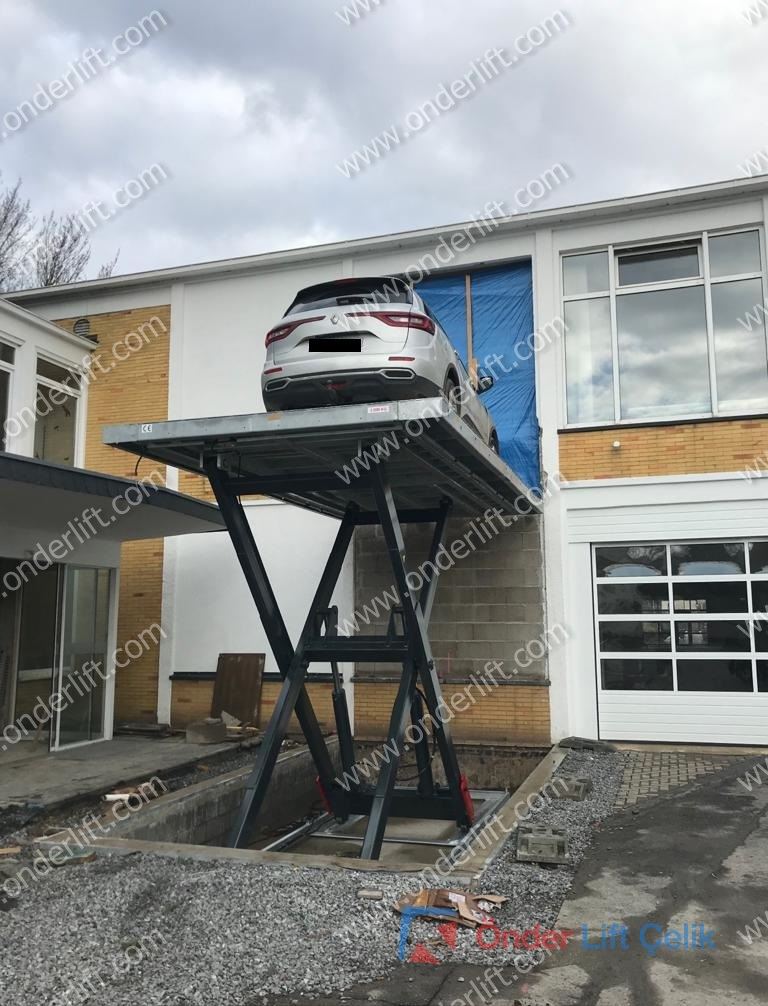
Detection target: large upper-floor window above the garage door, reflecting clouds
<box><xmin>563</xmin><ymin>230</ymin><xmax>768</xmax><ymax>424</ymax></box>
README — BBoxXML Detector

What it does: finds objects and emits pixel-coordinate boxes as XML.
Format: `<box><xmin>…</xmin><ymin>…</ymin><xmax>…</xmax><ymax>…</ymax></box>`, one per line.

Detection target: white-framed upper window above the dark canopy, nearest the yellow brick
<box><xmin>34</xmin><ymin>357</ymin><xmax>81</xmax><ymax>465</ymax></box>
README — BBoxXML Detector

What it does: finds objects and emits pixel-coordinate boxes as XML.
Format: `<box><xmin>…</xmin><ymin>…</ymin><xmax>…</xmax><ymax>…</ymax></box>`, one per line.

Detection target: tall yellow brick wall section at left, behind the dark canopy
<box><xmin>56</xmin><ymin>304</ymin><xmax>171</xmax><ymax>722</ymax></box>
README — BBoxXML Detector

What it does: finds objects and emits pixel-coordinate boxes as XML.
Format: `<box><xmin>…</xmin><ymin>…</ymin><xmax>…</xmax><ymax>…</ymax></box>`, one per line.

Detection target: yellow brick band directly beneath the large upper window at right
<box><xmin>560</xmin><ymin>418</ymin><xmax>768</xmax><ymax>481</ymax></box>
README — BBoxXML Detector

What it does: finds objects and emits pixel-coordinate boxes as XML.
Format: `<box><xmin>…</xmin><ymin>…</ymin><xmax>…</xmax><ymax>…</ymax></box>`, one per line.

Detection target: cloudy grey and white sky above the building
<box><xmin>0</xmin><ymin>0</ymin><xmax>768</xmax><ymax>273</ymax></box>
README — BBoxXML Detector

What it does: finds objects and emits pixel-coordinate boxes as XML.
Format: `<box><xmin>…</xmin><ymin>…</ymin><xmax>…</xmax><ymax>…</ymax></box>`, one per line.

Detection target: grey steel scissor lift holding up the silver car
<box><xmin>104</xmin><ymin>398</ymin><xmax>539</xmax><ymax>859</ymax></box>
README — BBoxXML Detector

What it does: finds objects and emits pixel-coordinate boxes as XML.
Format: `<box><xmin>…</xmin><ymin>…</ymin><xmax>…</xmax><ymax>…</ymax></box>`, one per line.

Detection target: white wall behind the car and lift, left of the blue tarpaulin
<box><xmin>158</xmin><ymin>235</ymin><xmax>533</xmax><ymax>721</ymax></box>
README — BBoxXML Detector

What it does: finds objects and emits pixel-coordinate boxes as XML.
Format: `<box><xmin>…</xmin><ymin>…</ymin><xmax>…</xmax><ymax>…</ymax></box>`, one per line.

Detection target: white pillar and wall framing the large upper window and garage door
<box><xmin>533</xmin><ymin>197</ymin><xmax>768</xmax><ymax>740</ymax></box>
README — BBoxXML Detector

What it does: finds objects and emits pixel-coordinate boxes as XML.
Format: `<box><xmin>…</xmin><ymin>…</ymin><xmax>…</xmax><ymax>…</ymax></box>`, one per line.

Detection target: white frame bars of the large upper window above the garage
<box><xmin>559</xmin><ymin>224</ymin><xmax>768</xmax><ymax>430</ymax></box>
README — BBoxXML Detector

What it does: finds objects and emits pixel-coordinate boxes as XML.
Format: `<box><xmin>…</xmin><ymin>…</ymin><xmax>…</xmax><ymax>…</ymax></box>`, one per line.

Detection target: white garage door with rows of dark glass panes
<box><xmin>593</xmin><ymin>540</ymin><xmax>768</xmax><ymax>744</ymax></box>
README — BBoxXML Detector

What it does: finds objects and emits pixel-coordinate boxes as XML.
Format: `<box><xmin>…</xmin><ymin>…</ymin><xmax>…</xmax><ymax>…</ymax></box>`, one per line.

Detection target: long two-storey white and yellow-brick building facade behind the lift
<box><xmin>15</xmin><ymin>178</ymin><xmax>768</xmax><ymax>743</ymax></box>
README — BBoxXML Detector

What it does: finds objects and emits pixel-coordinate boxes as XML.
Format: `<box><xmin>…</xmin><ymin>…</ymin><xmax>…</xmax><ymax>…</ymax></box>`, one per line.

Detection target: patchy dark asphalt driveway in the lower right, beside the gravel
<box><xmin>301</xmin><ymin>758</ymin><xmax>768</xmax><ymax>1006</ymax></box>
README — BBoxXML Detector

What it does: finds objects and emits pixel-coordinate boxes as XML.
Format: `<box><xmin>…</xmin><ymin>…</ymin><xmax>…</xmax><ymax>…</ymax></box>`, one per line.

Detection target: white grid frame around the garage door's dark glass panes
<box><xmin>590</xmin><ymin>537</ymin><xmax>768</xmax><ymax>697</ymax></box>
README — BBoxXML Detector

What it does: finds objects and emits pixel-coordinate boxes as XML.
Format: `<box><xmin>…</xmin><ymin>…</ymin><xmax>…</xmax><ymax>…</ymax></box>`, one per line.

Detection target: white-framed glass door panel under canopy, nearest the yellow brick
<box><xmin>56</xmin><ymin>565</ymin><xmax>110</xmax><ymax>747</ymax></box>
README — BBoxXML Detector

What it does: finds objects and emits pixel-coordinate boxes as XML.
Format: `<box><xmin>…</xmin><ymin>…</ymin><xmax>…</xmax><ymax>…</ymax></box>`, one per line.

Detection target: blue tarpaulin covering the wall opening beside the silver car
<box><xmin>419</xmin><ymin>261</ymin><xmax>541</xmax><ymax>489</ymax></box>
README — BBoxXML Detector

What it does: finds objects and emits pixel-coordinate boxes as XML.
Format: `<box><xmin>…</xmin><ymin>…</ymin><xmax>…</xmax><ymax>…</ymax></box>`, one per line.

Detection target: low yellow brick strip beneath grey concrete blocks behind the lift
<box><xmin>354</xmin><ymin>681</ymin><xmax>551</xmax><ymax>744</ymax></box>
